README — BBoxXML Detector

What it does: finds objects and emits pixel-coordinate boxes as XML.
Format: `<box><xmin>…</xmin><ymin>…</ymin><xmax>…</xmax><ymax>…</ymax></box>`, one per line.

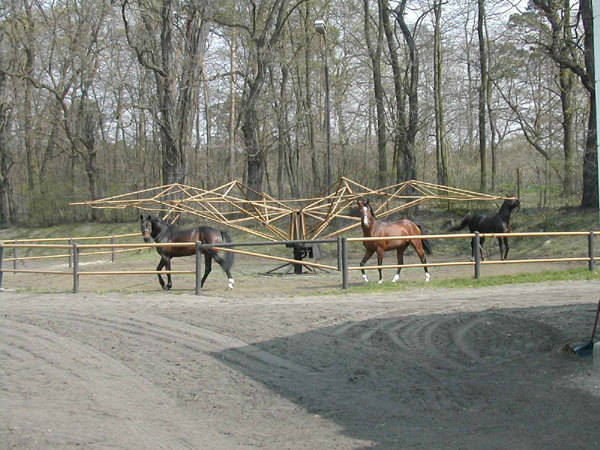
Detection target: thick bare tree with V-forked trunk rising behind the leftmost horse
<box><xmin>121</xmin><ymin>0</ymin><xmax>212</xmax><ymax>184</ymax></box>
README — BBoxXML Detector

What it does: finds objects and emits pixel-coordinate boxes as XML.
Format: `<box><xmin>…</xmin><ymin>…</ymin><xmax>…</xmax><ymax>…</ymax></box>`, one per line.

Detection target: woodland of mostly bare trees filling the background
<box><xmin>0</xmin><ymin>0</ymin><xmax>598</xmax><ymax>227</ymax></box>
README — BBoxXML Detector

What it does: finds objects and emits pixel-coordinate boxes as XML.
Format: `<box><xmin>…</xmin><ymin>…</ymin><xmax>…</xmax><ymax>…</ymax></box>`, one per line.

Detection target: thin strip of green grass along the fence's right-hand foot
<box><xmin>326</xmin><ymin>268</ymin><xmax>600</xmax><ymax>295</ymax></box>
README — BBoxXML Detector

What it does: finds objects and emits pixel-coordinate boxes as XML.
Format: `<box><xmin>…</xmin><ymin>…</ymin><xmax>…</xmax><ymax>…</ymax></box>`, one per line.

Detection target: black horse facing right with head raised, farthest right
<box><xmin>450</xmin><ymin>198</ymin><xmax>521</xmax><ymax>260</ymax></box>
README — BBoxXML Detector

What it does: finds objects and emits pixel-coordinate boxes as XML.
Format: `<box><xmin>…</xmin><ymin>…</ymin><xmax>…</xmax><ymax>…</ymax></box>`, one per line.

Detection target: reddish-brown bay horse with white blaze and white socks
<box><xmin>358</xmin><ymin>200</ymin><xmax>431</xmax><ymax>283</ymax></box>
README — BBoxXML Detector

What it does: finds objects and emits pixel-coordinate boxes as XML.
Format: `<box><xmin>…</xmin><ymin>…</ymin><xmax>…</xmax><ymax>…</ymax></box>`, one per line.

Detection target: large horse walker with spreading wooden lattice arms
<box><xmin>71</xmin><ymin>177</ymin><xmax>510</xmax><ymax>286</ymax></box>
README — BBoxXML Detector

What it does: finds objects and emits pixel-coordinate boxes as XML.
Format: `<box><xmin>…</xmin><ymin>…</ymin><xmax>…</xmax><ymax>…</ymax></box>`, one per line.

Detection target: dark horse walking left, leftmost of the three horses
<box><xmin>140</xmin><ymin>214</ymin><xmax>234</xmax><ymax>290</ymax></box>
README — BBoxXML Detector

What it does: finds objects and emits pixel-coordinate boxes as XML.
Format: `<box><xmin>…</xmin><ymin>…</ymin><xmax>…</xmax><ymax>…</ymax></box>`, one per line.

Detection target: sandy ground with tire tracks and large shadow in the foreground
<box><xmin>0</xmin><ymin>253</ymin><xmax>600</xmax><ymax>449</ymax></box>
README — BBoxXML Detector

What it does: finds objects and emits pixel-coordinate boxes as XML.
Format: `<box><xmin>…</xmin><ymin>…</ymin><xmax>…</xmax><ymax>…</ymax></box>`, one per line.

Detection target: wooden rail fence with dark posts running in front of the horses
<box><xmin>0</xmin><ymin>231</ymin><xmax>600</xmax><ymax>295</ymax></box>
